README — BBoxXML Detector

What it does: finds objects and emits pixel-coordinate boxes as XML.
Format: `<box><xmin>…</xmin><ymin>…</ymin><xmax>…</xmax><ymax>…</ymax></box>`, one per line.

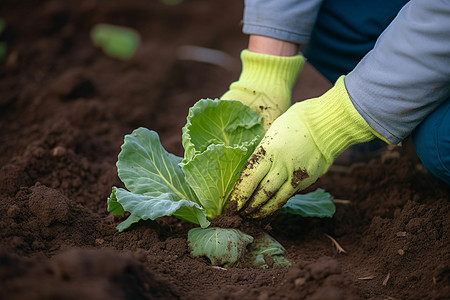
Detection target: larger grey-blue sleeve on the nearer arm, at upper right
<box><xmin>345</xmin><ymin>0</ymin><xmax>450</xmax><ymax>144</ymax></box>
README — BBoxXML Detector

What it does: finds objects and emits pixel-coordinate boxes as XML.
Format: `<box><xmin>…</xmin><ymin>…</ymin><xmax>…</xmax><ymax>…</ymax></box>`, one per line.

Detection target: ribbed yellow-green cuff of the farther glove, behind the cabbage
<box><xmin>239</xmin><ymin>50</ymin><xmax>305</xmax><ymax>94</ymax></box>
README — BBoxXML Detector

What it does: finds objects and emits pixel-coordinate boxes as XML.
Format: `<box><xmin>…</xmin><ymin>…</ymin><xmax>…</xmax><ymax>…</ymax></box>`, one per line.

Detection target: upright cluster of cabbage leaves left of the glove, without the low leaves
<box><xmin>108</xmin><ymin>99</ymin><xmax>264</xmax><ymax>231</ymax></box>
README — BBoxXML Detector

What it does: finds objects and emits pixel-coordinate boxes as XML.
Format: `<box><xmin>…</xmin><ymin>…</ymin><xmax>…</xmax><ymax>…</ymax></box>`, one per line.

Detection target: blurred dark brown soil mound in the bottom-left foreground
<box><xmin>0</xmin><ymin>249</ymin><xmax>179</xmax><ymax>300</ymax></box>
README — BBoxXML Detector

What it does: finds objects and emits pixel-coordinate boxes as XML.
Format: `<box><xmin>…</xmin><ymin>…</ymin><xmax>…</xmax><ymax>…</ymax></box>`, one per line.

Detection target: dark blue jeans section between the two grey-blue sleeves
<box><xmin>303</xmin><ymin>0</ymin><xmax>408</xmax><ymax>83</ymax></box>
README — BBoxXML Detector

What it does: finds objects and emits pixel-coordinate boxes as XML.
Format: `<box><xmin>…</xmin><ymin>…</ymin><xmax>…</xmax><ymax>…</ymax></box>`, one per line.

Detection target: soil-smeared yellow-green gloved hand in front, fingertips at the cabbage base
<box><xmin>229</xmin><ymin>76</ymin><xmax>380</xmax><ymax>218</ymax></box>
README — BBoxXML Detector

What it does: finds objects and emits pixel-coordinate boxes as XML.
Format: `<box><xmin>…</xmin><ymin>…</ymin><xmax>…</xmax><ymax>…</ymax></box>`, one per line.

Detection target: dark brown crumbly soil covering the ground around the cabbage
<box><xmin>0</xmin><ymin>0</ymin><xmax>450</xmax><ymax>299</ymax></box>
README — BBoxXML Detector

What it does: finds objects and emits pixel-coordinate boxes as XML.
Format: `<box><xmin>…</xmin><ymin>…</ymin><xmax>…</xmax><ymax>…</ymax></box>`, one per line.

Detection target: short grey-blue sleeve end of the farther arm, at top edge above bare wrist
<box><xmin>243</xmin><ymin>0</ymin><xmax>322</xmax><ymax>45</ymax></box>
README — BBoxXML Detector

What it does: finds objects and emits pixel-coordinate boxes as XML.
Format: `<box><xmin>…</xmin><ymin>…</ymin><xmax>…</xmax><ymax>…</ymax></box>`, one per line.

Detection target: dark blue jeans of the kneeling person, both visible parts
<box><xmin>303</xmin><ymin>0</ymin><xmax>450</xmax><ymax>184</ymax></box>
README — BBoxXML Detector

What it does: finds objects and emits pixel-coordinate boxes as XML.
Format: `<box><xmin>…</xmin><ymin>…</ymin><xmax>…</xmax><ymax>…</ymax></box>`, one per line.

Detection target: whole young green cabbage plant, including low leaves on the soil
<box><xmin>108</xmin><ymin>99</ymin><xmax>335</xmax><ymax>268</ymax></box>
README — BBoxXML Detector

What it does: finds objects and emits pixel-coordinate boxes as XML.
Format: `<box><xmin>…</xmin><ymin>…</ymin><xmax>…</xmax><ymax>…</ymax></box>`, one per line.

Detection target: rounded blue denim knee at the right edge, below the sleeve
<box><xmin>412</xmin><ymin>100</ymin><xmax>450</xmax><ymax>185</ymax></box>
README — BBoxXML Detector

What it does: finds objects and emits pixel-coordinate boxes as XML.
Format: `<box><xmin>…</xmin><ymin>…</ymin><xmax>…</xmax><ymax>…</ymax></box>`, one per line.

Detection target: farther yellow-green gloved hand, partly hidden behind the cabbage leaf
<box><xmin>220</xmin><ymin>50</ymin><xmax>305</xmax><ymax>130</ymax></box>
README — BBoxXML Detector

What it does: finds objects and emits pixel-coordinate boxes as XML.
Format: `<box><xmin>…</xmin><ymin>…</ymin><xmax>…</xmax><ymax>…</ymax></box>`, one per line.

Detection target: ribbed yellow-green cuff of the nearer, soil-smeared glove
<box><xmin>296</xmin><ymin>76</ymin><xmax>377</xmax><ymax>166</ymax></box>
